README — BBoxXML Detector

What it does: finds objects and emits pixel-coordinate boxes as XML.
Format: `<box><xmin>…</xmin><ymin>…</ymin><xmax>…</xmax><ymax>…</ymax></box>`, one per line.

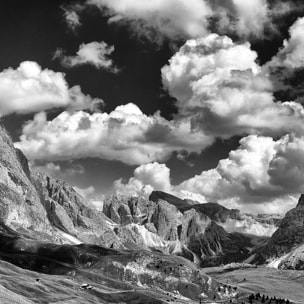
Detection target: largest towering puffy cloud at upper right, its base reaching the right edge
<box><xmin>162</xmin><ymin>34</ymin><xmax>304</xmax><ymax>137</ymax></box>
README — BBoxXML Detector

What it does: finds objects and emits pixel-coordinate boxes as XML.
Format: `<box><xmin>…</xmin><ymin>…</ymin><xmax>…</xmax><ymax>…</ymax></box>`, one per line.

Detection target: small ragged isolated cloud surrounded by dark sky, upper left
<box><xmin>54</xmin><ymin>41</ymin><xmax>118</xmax><ymax>72</ymax></box>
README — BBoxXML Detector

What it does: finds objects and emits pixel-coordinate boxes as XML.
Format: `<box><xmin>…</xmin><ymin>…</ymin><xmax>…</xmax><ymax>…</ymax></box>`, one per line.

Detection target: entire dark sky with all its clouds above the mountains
<box><xmin>0</xmin><ymin>0</ymin><xmax>304</xmax><ymax>213</ymax></box>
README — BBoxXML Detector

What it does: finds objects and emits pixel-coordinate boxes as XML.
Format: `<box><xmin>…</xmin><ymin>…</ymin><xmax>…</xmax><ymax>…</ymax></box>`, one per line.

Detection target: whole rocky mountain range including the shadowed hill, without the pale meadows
<box><xmin>0</xmin><ymin>125</ymin><xmax>304</xmax><ymax>303</ymax></box>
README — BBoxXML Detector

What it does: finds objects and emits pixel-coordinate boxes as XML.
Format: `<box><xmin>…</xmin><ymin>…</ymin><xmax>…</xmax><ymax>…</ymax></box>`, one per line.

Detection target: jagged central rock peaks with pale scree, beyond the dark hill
<box><xmin>104</xmin><ymin>192</ymin><xmax>255</xmax><ymax>266</ymax></box>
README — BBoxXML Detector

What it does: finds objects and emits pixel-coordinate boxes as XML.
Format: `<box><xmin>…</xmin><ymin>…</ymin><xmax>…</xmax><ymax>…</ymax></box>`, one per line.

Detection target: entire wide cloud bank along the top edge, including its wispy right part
<box><xmin>84</xmin><ymin>0</ymin><xmax>271</xmax><ymax>39</ymax></box>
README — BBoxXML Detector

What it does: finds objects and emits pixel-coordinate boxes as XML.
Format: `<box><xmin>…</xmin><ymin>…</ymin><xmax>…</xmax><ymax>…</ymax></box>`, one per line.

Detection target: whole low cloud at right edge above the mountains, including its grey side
<box><xmin>175</xmin><ymin>135</ymin><xmax>304</xmax><ymax>212</ymax></box>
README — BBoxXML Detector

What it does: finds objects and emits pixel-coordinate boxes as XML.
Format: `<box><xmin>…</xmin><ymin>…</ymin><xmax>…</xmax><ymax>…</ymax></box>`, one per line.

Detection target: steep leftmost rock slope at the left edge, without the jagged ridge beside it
<box><xmin>0</xmin><ymin>125</ymin><xmax>51</xmax><ymax>233</ymax></box>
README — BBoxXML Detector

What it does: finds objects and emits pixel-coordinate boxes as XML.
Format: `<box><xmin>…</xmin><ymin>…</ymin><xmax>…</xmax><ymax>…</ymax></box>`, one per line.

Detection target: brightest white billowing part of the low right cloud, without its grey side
<box><xmin>178</xmin><ymin>135</ymin><xmax>280</xmax><ymax>201</ymax></box>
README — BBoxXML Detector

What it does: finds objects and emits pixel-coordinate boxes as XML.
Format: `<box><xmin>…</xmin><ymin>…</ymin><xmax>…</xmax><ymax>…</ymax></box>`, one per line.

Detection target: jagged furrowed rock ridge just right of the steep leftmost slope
<box><xmin>33</xmin><ymin>173</ymin><xmax>121</xmax><ymax>248</ymax></box>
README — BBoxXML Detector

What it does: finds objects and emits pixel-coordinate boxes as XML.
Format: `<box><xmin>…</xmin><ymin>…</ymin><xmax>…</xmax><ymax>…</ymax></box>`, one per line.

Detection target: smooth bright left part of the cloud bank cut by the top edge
<box><xmin>88</xmin><ymin>0</ymin><xmax>212</xmax><ymax>38</ymax></box>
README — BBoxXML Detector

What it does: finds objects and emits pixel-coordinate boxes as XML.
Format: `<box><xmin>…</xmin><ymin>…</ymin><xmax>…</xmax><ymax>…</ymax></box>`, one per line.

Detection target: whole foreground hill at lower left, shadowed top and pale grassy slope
<box><xmin>0</xmin><ymin>225</ymin><xmax>242</xmax><ymax>304</ymax></box>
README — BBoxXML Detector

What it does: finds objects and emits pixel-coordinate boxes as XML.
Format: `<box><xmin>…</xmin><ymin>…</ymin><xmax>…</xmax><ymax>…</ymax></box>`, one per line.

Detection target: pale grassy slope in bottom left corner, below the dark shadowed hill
<box><xmin>0</xmin><ymin>262</ymin><xmax>195</xmax><ymax>304</ymax></box>
